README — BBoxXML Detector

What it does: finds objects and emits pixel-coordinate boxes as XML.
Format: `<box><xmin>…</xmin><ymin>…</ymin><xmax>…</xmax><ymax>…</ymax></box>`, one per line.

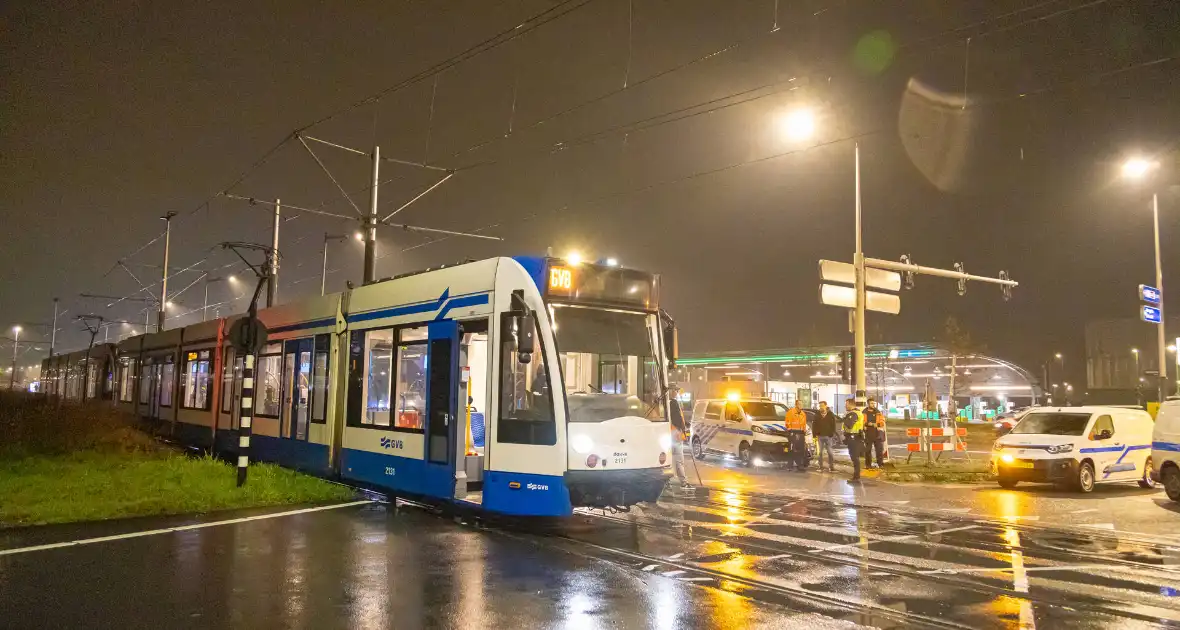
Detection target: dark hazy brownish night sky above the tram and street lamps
<box><xmin>0</xmin><ymin>0</ymin><xmax>1180</xmax><ymax>379</ymax></box>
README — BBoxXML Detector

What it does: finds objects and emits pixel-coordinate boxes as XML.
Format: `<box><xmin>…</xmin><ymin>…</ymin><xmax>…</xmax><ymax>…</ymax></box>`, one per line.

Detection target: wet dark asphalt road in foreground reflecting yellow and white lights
<box><xmin>0</xmin><ymin>470</ymin><xmax>1180</xmax><ymax>629</ymax></box>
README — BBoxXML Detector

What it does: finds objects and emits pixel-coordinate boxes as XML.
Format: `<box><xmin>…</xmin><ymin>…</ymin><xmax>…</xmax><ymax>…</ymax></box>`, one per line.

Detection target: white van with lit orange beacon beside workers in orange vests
<box><xmin>690</xmin><ymin>398</ymin><xmax>814</xmax><ymax>466</ymax></box>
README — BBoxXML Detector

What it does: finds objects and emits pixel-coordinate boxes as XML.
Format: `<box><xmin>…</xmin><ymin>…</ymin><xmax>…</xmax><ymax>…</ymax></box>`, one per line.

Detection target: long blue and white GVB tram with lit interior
<box><xmin>50</xmin><ymin>257</ymin><xmax>675</xmax><ymax>516</ymax></box>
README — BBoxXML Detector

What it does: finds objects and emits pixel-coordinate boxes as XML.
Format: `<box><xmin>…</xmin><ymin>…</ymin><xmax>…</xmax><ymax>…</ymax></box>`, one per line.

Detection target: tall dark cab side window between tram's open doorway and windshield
<box><xmin>497</xmin><ymin>313</ymin><xmax>557</xmax><ymax>445</ymax></box>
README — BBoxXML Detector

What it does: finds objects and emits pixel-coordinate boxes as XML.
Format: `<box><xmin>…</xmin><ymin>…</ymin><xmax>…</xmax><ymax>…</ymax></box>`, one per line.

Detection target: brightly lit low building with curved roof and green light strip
<box><xmin>671</xmin><ymin>343</ymin><xmax>1047</xmax><ymax>419</ymax></box>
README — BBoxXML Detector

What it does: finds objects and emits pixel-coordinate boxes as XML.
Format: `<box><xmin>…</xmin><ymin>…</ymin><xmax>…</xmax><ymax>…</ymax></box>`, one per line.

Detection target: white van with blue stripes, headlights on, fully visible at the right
<box><xmin>991</xmin><ymin>407</ymin><xmax>1155</xmax><ymax>492</ymax></box>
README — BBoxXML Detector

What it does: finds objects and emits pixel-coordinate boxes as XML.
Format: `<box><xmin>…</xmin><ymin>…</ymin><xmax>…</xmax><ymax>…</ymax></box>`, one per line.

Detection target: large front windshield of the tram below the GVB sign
<box><xmin>553</xmin><ymin>304</ymin><xmax>667</xmax><ymax>422</ymax></box>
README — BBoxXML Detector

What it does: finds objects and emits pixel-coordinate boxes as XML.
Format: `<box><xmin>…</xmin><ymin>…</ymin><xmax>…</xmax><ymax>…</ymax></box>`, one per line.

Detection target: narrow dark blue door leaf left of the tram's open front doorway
<box><xmin>426</xmin><ymin>321</ymin><xmax>459</xmax><ymax>497</ymax></box>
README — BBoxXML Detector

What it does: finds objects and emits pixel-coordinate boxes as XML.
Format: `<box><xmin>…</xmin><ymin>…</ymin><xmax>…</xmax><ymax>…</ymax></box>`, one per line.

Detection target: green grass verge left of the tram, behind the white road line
<box><xmin>0</xmin><ymin>452</ymin><xmax>353</xmax><ymax>527</ymax></box>
